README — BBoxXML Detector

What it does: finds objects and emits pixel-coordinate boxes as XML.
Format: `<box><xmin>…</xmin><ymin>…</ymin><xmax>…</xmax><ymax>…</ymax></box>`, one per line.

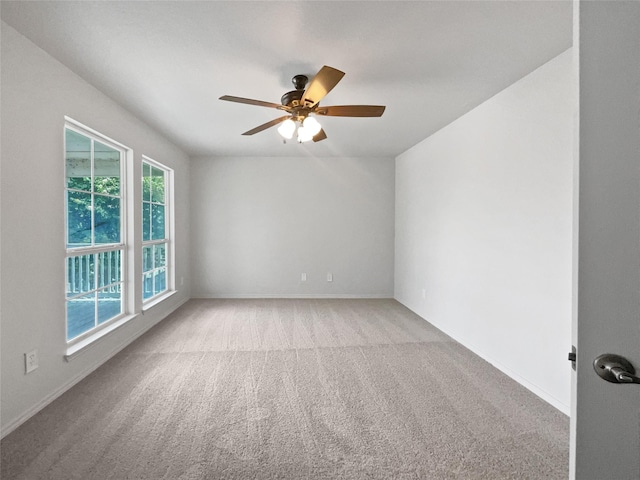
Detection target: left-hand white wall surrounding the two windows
<box><xmin>0</xmin><ymin>23</ymin><xmax>189</xmax><ymax>434</ymax></box>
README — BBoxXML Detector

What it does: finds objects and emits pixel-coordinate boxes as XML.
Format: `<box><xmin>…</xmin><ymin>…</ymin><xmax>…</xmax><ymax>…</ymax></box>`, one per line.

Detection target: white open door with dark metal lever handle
<box><xmin>572</xmin><ymin>1</ymin><xmax>640</xmax><ymax>480</ymax></box>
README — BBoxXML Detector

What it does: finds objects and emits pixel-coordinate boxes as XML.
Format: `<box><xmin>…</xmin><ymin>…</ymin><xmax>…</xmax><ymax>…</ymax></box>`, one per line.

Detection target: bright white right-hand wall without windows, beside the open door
<box><xmin>395</xmin><ymin>51</ymin><xmax>575</xmax><ymax>413</ymax></box>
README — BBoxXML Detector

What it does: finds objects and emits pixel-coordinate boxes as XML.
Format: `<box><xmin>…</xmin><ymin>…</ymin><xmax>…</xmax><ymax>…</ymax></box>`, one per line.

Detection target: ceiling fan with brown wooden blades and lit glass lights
<box><xmin>220</xmin><ymin>65</ymin><xmax>385</xmax><ymax>143</ymax></box>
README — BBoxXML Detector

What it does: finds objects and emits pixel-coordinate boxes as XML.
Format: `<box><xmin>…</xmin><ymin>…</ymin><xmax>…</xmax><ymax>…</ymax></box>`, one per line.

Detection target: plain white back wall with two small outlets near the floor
<box><xmin>191</xmin><ymin>157</ymin><xmax>395</xmax><ymax>298</ymax></box>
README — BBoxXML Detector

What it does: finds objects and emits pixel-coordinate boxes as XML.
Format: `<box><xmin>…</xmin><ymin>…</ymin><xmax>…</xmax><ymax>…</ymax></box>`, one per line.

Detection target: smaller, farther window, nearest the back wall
<box><xmin>142</xmin><ymin>158</ymin><xmax>172</xmax><ymax>302</ymax></box>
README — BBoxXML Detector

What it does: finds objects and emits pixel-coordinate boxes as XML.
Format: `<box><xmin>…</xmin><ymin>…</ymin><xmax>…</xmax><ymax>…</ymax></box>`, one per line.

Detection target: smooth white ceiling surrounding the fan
<box><xmin>0</xmin><ymin>0</ymin><xmax>572</xmax><ymax>157</ymax></box>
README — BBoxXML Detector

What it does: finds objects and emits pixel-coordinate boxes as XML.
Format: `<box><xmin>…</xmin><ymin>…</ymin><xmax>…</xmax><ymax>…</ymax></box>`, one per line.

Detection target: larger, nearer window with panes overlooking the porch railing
<box><xmin>65</xmin><ymin>124</ymin><xmax>126</xmax><ymax>341</ymax></box>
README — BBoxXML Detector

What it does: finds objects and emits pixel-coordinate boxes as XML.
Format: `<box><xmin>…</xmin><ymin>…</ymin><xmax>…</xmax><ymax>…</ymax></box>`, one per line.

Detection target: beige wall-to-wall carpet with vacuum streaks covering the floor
<box><xmin>1</xmin><ymin>299</ymin><xmax>569</xmax><ymax>480</ymax></box>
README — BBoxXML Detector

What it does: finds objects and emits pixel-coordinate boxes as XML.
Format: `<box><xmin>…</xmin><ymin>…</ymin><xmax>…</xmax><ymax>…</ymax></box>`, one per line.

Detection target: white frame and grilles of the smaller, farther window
<box><xmin>139</xmin><ymin>155</ymin><xmax>175</xmax><ymax>304</ymax></box>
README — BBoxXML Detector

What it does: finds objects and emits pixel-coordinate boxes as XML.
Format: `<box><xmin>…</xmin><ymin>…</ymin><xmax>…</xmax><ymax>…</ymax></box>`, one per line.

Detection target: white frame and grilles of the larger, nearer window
<box><xmin>63</xmin><ymin>117</ymin><xmax>132</xmax><ymax>348</ymax></box>
